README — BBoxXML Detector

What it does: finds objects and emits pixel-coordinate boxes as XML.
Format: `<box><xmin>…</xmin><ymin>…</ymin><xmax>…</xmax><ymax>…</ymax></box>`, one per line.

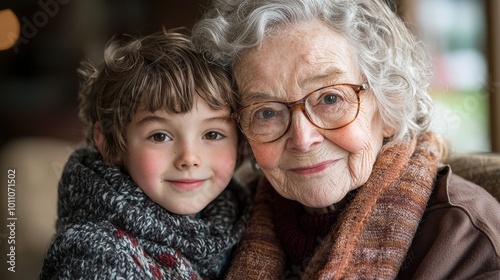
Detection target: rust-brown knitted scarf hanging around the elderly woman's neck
<box><xmin>227</xmin><ymin>133</ymin><xmax>440</xmax><ymax>279</ymax></box>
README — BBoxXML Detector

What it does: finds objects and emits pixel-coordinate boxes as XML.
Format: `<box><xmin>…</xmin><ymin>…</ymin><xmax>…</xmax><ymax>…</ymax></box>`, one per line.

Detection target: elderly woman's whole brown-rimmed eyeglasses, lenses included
<box><xmin>231</xmin><ymin>83</ymin><xmax>369</xmax><ymax>143</ymax></box>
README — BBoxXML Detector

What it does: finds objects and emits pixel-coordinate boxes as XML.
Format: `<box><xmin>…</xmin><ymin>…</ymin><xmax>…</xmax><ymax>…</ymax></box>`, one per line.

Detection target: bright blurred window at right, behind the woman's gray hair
<box><xmin>402</xmin><ymin>0</ymin><xmax>491</xmax><ymax>152</ymax></box>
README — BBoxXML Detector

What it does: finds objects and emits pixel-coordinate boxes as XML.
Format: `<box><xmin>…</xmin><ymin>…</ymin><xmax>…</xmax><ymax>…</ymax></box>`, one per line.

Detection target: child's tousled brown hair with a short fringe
<box><xmin>78</xmin><ymin>30</ymin><xmax>238</xmax><ymax>164</ymax></box>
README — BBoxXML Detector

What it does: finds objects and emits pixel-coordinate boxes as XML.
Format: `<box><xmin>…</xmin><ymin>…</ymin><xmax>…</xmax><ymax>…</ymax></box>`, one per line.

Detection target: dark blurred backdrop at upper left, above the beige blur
<box><xmin>0</xmin><ymin>0</ymin><xmax>208</xmax><ymax>147</ymax></box>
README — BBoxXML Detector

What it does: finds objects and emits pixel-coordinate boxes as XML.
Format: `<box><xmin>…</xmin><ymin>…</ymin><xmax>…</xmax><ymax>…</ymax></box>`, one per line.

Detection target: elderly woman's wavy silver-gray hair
<box><xmin>192</xmin><ymin>0</ymin><xmax>433</xmax><ymax>144</ymax></box>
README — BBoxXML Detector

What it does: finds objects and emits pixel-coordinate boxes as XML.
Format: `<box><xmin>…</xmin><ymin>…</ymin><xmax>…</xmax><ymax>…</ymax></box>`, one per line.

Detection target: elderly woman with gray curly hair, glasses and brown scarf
<box><xmin>193</xmin><ymin>0</ymin><xmax>500</xmax><ymax>279</ymax></box>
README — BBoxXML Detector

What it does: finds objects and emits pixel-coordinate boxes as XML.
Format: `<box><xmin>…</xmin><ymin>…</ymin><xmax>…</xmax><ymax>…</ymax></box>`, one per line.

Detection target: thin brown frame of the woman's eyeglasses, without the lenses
<box><xmin>231</xmin><ymin>82</ymin><xmax>370</xmax><ymax>144</ymax></box>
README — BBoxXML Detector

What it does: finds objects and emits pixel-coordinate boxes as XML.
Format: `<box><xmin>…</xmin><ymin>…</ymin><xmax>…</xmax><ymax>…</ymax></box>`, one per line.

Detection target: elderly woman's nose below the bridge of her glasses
<box><xmin>286</xmin><ymin>110</ymin><xmax>324</xmax><ymax>152</ymax></box>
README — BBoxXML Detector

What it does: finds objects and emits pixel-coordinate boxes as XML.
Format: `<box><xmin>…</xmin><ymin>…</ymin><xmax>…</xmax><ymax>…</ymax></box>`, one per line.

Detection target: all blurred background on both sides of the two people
<box><xmin>0</xmin><ymin>0</ymin><xmax>500</xmax><ymax>279</ymax></box>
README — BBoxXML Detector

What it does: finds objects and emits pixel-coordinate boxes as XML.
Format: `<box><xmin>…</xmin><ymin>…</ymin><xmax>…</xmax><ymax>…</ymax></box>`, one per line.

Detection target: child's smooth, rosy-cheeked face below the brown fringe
<box><xmin>122</xmin><ymin>98</ymin><xmax>238</xmax><ymax>215</ymax></box>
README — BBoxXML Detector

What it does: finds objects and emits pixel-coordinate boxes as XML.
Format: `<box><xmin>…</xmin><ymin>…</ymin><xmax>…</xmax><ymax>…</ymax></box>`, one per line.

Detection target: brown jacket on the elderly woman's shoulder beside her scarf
<box><xmin>398</xmin><ymin>166</ymin><xmax>500</xmax><ymax>279</ymax></box>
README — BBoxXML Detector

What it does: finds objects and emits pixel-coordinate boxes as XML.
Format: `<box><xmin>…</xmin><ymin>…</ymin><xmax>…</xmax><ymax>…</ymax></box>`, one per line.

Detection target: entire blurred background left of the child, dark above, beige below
<box><xmin>0</xmin><ymin>0</ymin><xmax>208</xmax><ymax>279</ymax></box>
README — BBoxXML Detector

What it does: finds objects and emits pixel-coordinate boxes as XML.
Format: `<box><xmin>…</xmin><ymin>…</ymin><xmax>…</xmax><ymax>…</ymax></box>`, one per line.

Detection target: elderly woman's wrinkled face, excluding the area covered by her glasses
<box><xmin>234</xmin><ymin>21</ymin><xmax>390</xmax><ymax>208</ymax></box>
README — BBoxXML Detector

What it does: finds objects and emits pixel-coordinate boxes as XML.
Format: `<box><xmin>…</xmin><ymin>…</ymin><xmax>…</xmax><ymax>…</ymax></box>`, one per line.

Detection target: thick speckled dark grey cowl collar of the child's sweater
<box><xmin>49</xmin><ymin>148</ymin><xmax>250</xmax><ymax>279</ymax></box>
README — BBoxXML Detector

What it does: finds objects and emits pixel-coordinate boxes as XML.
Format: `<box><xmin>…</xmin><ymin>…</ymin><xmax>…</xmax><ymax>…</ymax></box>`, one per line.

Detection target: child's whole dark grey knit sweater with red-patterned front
<box><xmin>40</xmin><ymin>148</ymin><xmax>250</xmax><ymax>279</ymax></box>
